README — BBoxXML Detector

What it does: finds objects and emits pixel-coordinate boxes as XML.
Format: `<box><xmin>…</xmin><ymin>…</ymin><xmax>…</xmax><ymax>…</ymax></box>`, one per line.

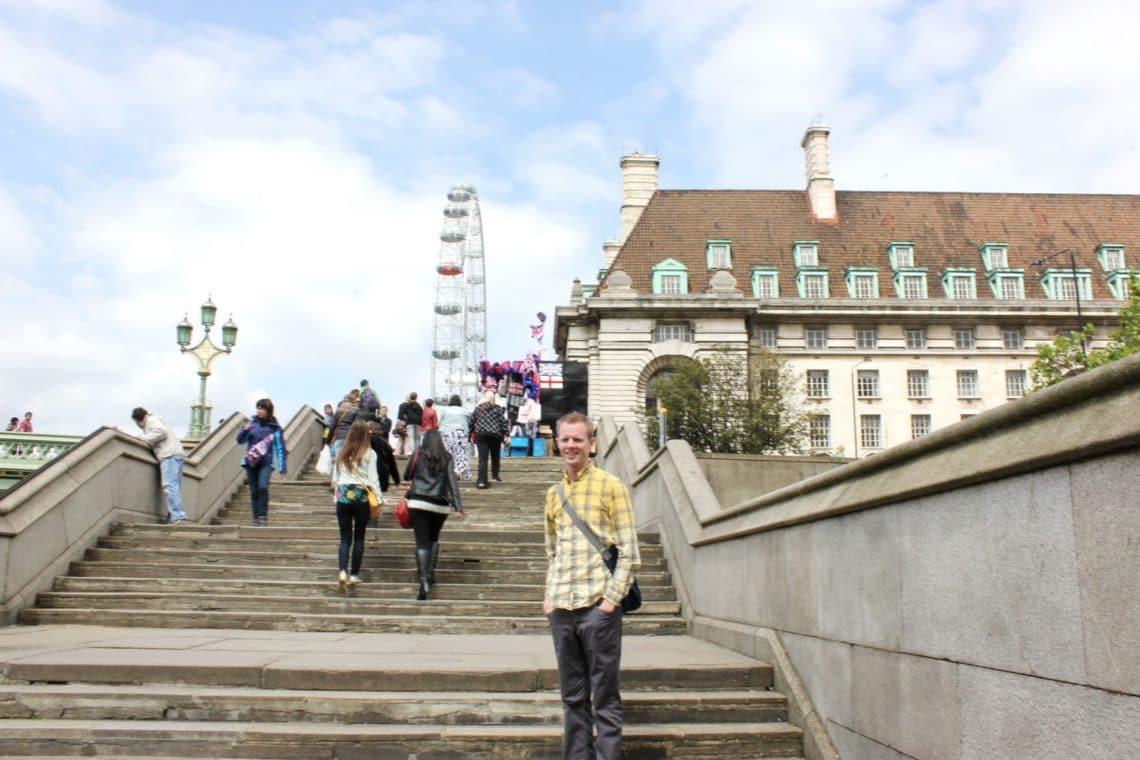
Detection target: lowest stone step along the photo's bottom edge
<box><xmin>0</xmin><ymin>720</ymin><xmax>801</xmax><ymax>760</ymax></box>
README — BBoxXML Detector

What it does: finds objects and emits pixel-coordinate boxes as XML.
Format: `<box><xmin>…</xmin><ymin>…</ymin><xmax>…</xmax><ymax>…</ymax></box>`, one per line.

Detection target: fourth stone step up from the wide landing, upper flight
<box><xmin>68</xmin><ymin>562</ymin><xmax>673</xmax><ymax>588</ymax></box>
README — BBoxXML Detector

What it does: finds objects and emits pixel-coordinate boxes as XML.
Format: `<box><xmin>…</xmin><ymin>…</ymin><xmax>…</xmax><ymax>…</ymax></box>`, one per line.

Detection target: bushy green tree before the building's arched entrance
<box><xmin>641</xmin><ymin>349</ymin><xmax>812</xmax><ymax>453</ymax></box>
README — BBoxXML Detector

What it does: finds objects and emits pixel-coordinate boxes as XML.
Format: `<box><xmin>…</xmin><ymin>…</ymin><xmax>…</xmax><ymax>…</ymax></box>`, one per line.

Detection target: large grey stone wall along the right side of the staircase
<box><xmin>599</xmin><ymin>356</ymin><xmax>1140</xmax><ymax>760</ymax></box>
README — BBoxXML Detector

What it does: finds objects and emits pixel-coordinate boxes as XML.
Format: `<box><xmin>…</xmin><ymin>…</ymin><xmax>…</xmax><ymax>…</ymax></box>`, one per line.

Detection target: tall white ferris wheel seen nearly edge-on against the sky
<box><xmin>431</xmin><ymin>185</ymin><xmax>487</xmax><ymax>407</ymax></box>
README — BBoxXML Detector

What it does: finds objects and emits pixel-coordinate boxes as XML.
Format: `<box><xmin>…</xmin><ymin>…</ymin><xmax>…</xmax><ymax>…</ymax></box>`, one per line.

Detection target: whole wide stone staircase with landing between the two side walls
<box><xmin>0</xmin><ymin>458</ymin><xmax>803</xmax><ymax>760</ymax></box>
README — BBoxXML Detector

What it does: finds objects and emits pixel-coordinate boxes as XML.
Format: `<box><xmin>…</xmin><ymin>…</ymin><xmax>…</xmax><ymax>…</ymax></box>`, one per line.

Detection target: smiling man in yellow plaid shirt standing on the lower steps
<box><xmin>543</xmin><ymin>412</ymin><xmax>641</xmax><ymax>760</ymax></box>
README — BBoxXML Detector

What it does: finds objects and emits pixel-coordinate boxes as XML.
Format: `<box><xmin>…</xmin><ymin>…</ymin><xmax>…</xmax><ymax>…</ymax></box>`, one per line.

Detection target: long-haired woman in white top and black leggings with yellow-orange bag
<box><xmin>333</xmin><ymin>419</ymin><xmax>381</xmax><ymax>594</ymax></box>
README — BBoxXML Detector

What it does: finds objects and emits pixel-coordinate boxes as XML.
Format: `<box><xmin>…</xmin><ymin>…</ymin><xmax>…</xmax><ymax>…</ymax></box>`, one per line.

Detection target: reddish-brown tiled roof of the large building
<box><xmin>613</xmin><ymin>190</ymin><xmax>1140</xmax><ymax>300</ymax></box>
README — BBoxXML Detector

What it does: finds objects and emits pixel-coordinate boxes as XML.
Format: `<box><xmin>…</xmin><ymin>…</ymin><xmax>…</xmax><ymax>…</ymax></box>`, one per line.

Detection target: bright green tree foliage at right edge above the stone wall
<box><xmin>1029</xmin><ymin>277</ymin><xmax>1140</xmax><ymax>390</ymax></box>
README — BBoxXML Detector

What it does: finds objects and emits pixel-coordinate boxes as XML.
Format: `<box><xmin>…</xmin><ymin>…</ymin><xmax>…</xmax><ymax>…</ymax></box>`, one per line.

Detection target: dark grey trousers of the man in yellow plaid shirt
<box><xmin>548</xmin><ymin>605</ymin><xmax>621</xmax><ymax>760</ymax></box>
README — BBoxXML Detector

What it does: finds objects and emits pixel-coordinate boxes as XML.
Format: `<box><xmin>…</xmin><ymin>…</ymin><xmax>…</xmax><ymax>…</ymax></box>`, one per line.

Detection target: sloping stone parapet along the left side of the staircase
<box><xmin>0</xmin><ymin>407</ymin><xmax>321</xmax><ymax>623</ymax></box>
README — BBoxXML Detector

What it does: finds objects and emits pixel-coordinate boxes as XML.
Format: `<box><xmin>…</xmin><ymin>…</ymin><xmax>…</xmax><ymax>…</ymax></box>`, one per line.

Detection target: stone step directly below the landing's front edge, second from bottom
<box><xmin>0</xmin><ymin>684</ymin><xmax>788</xmax><ymax>732</ymax></box>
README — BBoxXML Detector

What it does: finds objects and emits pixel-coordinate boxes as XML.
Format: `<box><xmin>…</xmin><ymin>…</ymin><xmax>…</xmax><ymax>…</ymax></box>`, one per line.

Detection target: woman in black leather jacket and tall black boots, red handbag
<box><xmin>404</xmin><ymin>431</ymin><xmax>463</xmax><ymax>600</ymax></box>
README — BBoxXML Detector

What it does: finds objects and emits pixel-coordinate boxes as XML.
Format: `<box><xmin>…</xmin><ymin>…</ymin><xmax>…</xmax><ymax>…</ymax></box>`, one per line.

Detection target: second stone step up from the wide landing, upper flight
<box><xmin>36</xmin><ymin>592</ymin><xmax>681</xmax><ymax>618</ymax></box>
